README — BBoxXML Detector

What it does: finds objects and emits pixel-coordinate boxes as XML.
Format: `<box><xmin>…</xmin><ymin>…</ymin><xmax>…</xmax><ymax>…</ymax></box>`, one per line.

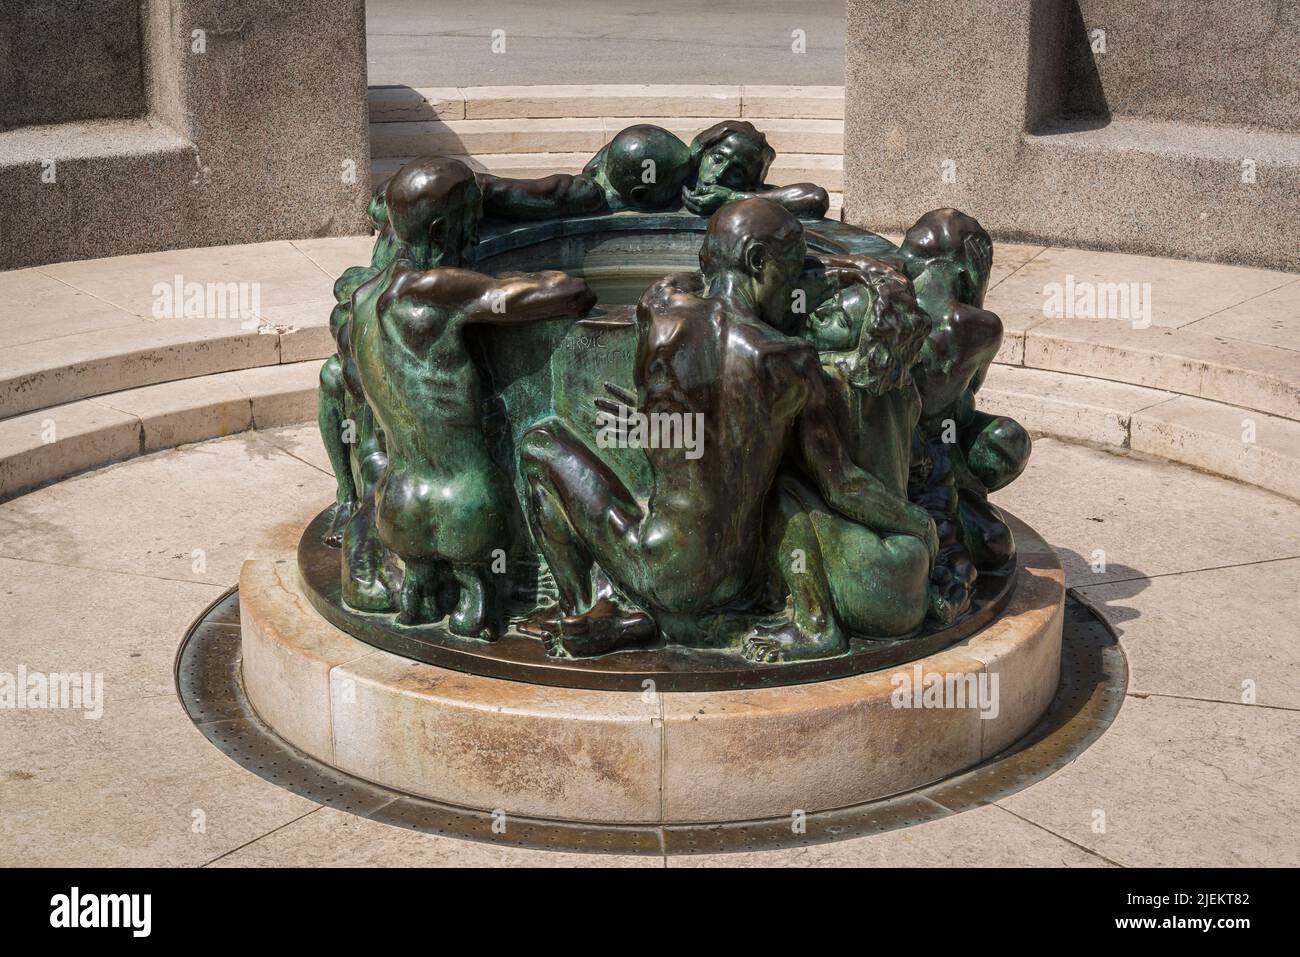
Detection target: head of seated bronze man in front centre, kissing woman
<box><xmin>699</xmin><ymin>199</ymin><xmax>807</xmax><ymax>328</ymax></box>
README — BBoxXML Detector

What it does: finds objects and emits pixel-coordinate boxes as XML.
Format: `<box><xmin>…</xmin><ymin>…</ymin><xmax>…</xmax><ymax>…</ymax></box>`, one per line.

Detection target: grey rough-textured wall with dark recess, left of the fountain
<box><xmin>0</xmin><ymin>0</ymin><xmax>369</xmax><ymax>268</ymax></box>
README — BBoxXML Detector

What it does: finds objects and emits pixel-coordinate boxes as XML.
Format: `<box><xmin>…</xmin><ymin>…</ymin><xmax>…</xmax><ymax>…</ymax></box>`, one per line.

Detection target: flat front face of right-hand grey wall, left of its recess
<box><xmin>844</xmin><ymin>0</ymin><xmax>1032</xmax><ymax>231</ymax></box>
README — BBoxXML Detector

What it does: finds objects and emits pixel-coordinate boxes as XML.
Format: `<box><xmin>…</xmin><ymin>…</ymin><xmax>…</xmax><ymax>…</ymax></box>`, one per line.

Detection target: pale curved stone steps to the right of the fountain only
<box><xmin>980</xmin><ymin>242</ymin><xmax>1300</xmax><ymax>499</ymax></box>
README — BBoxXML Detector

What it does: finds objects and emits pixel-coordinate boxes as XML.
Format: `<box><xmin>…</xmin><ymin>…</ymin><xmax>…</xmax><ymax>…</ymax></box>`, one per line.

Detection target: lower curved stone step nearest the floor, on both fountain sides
<box><xmin>0</xmin><ymin>351</ymin><xmax>1300</xmax><ymax>501</ymax></box>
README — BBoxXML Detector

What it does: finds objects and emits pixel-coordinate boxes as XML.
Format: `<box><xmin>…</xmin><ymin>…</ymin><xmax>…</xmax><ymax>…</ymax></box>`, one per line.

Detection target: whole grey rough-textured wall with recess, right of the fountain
<box><xmin>845</xmin><ymin>0</ymin><xmax>1300</xmax><ymax>269</ymax></box>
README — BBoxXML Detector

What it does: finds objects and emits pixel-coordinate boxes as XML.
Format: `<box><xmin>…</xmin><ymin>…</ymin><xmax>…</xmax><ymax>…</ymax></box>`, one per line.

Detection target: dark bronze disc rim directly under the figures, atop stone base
<box><xmin>298</xmin><ymin>510</ymin><xmax>1015</xmax><ymax>692</ymax></box>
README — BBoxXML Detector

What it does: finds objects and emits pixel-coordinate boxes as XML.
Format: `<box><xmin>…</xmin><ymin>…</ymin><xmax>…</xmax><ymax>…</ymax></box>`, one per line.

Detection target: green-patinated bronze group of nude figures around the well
<box><xmin>312</xmin><ymin>121</ymin><xmax>1030</xmax><ymax>662</ymax></box>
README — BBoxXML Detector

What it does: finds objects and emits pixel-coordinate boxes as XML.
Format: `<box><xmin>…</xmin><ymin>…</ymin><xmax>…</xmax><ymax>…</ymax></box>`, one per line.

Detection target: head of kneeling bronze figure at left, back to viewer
<box><xmin>384</xmin><ymin>156</ymin><xmax>482</xmax><ymax>269</ymax></box>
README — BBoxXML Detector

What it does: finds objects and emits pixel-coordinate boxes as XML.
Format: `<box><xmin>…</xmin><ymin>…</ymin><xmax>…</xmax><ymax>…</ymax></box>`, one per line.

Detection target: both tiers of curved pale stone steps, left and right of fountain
<box><xmin>0</xmin><ymin>230</ymin><xmax>1300</xmax><ymax>501</ymax></box>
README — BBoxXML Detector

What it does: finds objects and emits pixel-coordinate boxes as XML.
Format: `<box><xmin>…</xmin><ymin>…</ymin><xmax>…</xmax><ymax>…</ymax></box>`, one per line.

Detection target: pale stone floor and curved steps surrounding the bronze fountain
<box><xmin>0</xmin><ymin>238</ymin><xmax>1300</xmax><ymax>866</ymax></box>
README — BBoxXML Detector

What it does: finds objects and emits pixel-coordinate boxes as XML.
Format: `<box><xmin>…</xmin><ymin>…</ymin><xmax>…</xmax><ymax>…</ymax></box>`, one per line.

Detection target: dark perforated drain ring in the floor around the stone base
<box><xmin>176</xmin><ymin>589</ymin><xmax>1128</xmax><ymax>856</ymax></box>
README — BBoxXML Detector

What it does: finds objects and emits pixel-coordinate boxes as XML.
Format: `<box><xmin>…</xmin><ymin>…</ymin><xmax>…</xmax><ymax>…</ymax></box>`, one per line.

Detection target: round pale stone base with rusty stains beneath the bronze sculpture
<box><xmin>239</xmin><ymin>519</ymin><xmax>1065</xmax><ymax>824</ymax></box>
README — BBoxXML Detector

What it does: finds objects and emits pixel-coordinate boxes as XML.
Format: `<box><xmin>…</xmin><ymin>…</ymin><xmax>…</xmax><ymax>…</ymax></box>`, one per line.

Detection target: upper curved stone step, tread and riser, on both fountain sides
<box><xmin>10</xmin><ymin>237</ymin><xmax>1300</xmax><ymax>429</ymax></box>
